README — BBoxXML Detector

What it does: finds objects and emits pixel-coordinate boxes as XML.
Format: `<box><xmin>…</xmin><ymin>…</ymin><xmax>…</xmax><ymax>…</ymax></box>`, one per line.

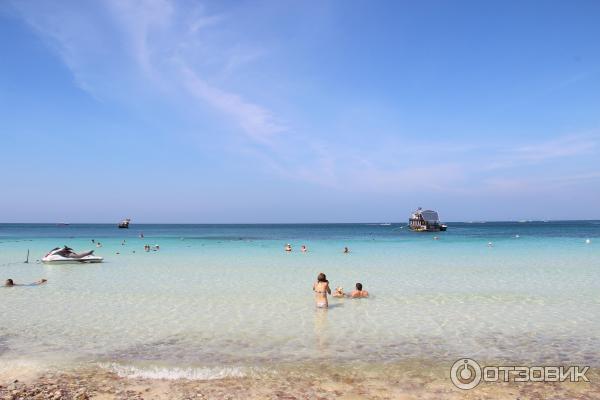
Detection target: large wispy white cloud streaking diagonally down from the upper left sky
<box><xmin>9</xmin><ymin>0</ymin><xmax>286</xmax><ymax>144</ymax></box>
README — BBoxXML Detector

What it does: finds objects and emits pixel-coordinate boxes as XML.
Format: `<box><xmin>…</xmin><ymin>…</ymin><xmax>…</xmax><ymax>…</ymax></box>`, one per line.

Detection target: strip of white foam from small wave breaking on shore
<box><xmin>99</xmin><ymin>363</ymin><xmax>248</xmax><ymax>381</ymax></box>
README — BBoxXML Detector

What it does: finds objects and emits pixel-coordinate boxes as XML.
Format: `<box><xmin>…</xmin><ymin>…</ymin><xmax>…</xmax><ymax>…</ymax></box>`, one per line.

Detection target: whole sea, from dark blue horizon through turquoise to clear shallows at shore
<box><xmin>0</xmin><ymin>221</ymin><xmax>600</xmax><ymax>379</ymax></box>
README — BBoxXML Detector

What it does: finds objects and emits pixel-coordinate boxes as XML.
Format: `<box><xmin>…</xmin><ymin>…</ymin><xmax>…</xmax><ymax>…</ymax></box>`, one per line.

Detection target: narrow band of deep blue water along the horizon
<box><xmin>0</xmin><ymin>220</ymin><xmax>600</xmax><ymax>242</ymax></box>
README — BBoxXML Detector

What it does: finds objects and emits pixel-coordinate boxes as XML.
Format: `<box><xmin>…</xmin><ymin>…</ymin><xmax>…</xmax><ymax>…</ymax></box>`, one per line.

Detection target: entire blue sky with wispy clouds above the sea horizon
<box><xmin>0</xmin><ymin>0</ymin><xmax>600</xmax><ymax>223</ymax></box>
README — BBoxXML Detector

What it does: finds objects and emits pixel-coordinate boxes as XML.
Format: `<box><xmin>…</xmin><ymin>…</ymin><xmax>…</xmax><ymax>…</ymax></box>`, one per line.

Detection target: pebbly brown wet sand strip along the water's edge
<box><xmin>0</xmin><ymin>362</ymin><xmax>600</xmax><ymax>400</ymax></box>
